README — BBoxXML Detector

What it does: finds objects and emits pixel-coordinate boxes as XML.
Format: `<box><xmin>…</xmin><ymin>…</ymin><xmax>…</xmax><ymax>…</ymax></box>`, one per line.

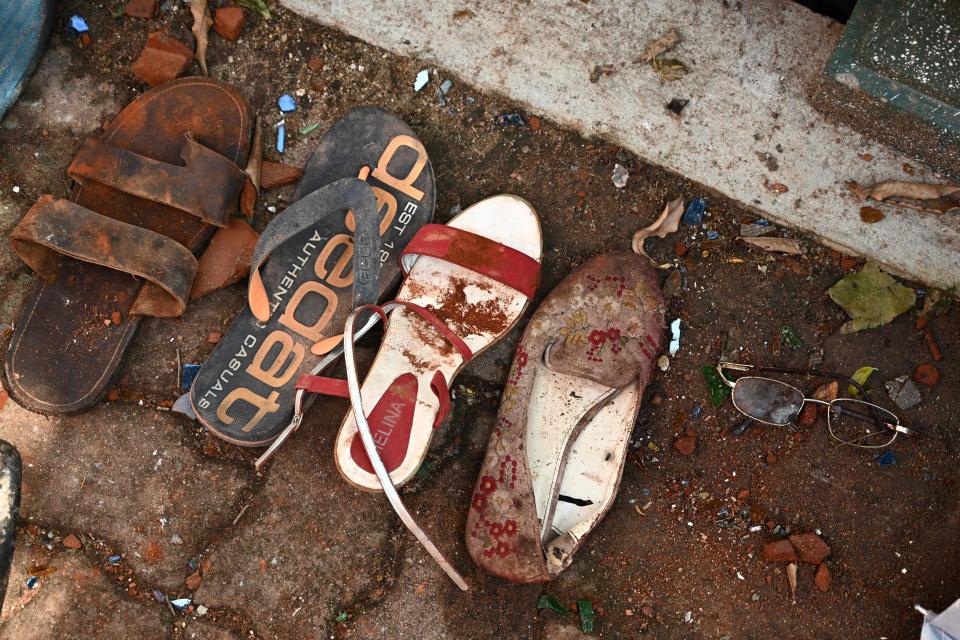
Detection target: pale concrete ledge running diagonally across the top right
<box><xmin>281</xmin><ymin>0</ymin><xmax>960</xmax><ymax>287</ymax></box>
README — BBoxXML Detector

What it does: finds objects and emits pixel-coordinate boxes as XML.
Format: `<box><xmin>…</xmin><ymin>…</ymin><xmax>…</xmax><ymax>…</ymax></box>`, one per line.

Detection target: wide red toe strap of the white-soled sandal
<box><xmin>400</xmin><ymin>224</ymin><xmax>540</xmax><ymax>298</ymax></box>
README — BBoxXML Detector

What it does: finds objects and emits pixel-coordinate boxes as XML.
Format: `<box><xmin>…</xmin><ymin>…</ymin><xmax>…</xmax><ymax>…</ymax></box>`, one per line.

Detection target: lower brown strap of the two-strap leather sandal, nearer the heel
<box><xmin>10</xmin><ymin>195</ymin><xmax>197</xmax><ymax>317</ymax></box>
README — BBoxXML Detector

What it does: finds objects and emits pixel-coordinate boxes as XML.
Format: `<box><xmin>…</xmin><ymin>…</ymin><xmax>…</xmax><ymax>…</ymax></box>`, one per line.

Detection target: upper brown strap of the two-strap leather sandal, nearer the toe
<box><xmin>67</xmin><ymin>133</ymin><xmax>246</xmax><ymax>227</ymax></box>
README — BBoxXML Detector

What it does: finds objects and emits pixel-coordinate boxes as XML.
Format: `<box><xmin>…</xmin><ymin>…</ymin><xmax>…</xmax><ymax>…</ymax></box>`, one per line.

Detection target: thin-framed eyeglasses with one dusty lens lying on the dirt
<box><xmin>717</xmin><ymin>361</ymin><xmax>917</xmax><ymax>449</ymax></box>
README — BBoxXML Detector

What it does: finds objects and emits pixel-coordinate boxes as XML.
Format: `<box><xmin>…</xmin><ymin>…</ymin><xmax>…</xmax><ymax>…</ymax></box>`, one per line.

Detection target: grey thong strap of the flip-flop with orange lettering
<box><xmin>247</xmin><ymin>178</ymin><xmax>380</xmax><ymax>322</ymax></box>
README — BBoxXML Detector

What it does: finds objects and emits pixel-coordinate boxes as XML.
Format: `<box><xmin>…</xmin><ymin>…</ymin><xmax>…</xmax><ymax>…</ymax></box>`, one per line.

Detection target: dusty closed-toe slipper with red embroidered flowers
<box><xmin>466</xmin><ymin>253</ymin><xmax>664</xmax><ymax>582</ymax></box>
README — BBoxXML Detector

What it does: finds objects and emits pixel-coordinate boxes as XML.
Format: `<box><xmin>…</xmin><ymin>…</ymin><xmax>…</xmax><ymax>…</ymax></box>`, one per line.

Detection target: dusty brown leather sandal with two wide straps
<box><xmin>6</xmin><ymin>78</ymin><xmax>253</xmax><ymax>413</ymax></box>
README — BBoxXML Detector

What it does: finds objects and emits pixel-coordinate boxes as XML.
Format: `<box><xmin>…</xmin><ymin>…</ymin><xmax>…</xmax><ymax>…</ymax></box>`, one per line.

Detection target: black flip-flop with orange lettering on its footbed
<box><xmin>190</xmin><ymin>107</ymin><xmax>435</xmax><ymax>446</ymax></box>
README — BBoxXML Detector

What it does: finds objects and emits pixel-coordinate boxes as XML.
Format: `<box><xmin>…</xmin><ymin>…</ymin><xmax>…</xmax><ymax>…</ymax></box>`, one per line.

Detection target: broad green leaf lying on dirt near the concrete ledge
<box><xmin>827</xmin><ymin>260</ymin><xmax>917</xmax><ymax>333</ymax></box>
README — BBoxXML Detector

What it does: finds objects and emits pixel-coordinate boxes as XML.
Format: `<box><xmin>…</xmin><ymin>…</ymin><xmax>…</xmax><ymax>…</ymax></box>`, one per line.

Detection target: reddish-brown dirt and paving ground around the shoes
<box><xmin>0</xmin><ymin>0</ymin><xmax>960</xmax><ymax>639</ymax></box>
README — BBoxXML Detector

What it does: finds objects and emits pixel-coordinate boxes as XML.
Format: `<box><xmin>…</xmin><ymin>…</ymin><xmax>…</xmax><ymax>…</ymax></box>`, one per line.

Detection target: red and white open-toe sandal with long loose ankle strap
<box><xmin>288</xmin><ymin>195</ymin><xmax>542</xmax><ymax>590</ymax></box>
